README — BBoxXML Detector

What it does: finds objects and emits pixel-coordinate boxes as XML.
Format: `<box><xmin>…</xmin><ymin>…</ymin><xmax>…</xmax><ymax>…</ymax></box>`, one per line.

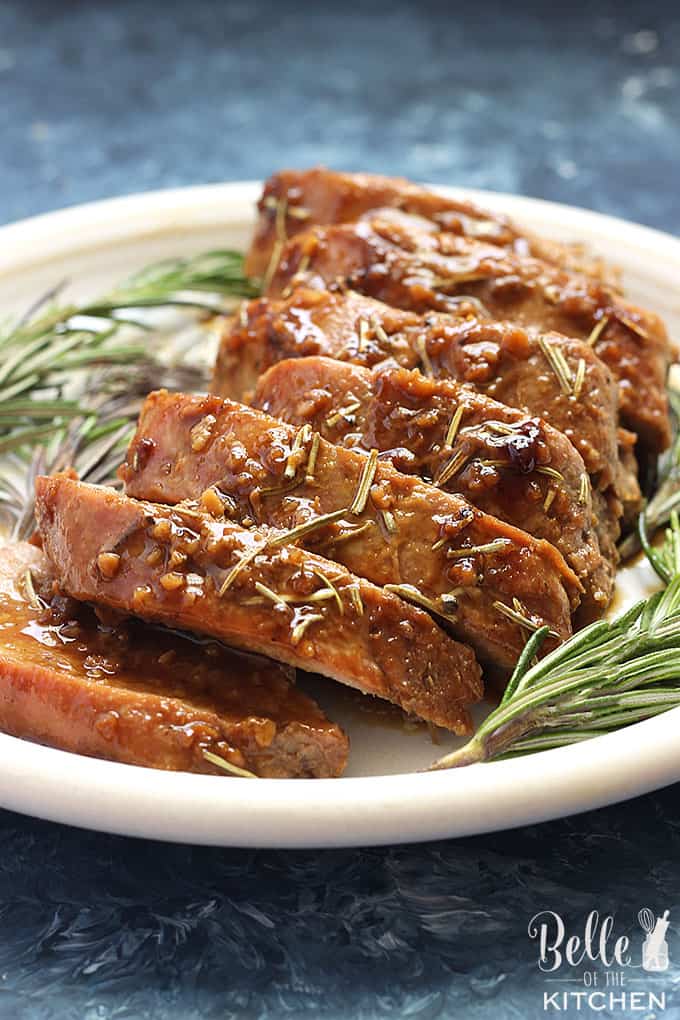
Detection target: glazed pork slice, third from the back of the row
<box><xmin>212</xmin><ymin>287</ymin><xmax>640</xmax><ymax>534</ymax></box>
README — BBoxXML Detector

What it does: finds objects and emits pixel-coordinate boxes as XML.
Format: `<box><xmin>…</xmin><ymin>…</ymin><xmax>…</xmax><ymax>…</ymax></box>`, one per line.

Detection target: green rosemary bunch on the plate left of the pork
<box><xmin>0</xmin><ymin>251</ymin><xmax>257</xmax><ymax>539</ymax></box>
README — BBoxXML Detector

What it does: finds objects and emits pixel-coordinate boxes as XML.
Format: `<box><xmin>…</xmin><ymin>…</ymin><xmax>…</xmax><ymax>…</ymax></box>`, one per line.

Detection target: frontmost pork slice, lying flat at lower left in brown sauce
<box><xmin>0</xmin><ymin>543</ymin><xmax>348</xmax><ymax>777</ymax></box>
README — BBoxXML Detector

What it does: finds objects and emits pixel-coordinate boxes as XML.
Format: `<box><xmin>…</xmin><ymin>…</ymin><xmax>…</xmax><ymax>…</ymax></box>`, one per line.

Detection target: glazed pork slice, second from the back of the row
<box><xmin>268</xmin><ymin>221</ymin><xmax>671</xmax><ymax>455</ymax></box>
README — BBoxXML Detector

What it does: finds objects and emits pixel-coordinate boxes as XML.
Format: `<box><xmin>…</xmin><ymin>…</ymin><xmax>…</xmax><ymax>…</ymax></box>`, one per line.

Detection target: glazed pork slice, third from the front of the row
<box><xmin>121</xmin><ymin>391</ymin><xmax>581</xmax><ymax>669</ymax></box>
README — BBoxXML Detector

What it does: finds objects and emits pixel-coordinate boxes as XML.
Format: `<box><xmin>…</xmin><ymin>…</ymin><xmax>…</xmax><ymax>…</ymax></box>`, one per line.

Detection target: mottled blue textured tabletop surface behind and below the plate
<box><xmin>0</xmin><ymin>0</ymin><xmax>680</xmax><ymax>1020</ymax></box>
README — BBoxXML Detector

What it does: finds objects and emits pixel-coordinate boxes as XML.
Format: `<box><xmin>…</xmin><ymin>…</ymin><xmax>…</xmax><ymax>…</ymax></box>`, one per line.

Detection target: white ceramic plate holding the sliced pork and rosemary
<box><xmin>0</xmin><ymin>184</ymin><xmax>680</xmax><ymax>847</ymax></box>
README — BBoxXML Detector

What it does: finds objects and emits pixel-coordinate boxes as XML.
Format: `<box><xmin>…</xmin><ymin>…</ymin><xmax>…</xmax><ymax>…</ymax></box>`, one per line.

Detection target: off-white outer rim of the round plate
<box><xmin>0</xmin><ymin>181</ymin><xmax>680</xmax><ymax>849</ymax></box>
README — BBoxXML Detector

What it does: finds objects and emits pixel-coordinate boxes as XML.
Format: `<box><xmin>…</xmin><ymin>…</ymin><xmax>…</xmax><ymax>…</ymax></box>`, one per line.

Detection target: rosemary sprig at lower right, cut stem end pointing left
<box><xmin>432</xmin><ymin>511</ymin><xmax>680</xmax><ymax>769</ymax></box>
